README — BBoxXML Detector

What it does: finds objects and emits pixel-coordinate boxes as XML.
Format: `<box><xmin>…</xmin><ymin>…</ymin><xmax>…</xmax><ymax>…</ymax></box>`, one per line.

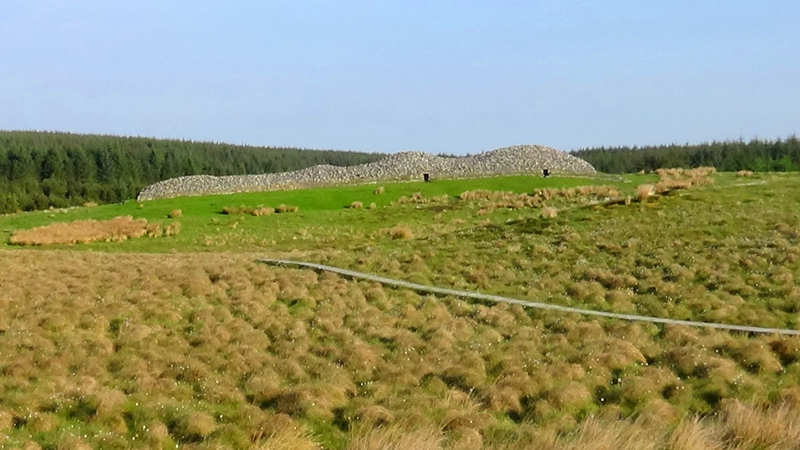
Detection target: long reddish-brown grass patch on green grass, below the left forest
<box><xmin>9</xmin><ymin>216</ymin><xmax>180</xmax><ymax>245</ymax></box>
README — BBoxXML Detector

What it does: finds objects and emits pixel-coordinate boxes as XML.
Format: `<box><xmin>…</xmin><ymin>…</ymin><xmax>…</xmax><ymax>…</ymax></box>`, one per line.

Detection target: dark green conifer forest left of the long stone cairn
<box><xmin>0</xmin><ymin>131</ymin><xmax>384</xmax><ymax>214</ymax></box>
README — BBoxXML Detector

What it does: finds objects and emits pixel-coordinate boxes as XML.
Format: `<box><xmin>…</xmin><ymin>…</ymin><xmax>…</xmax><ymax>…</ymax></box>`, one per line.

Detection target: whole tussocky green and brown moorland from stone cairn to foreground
<box><xmin>0</xmin><ymin>173</ymin><xmax>800</xmax><ymax>449</ymax></box>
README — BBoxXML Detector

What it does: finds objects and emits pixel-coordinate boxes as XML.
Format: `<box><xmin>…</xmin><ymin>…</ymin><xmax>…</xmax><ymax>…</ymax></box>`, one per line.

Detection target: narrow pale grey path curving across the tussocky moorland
<box><xmin>258</xmin><ymin>258</ymin><xmax>800</xmax><ymax>336</ymax></box>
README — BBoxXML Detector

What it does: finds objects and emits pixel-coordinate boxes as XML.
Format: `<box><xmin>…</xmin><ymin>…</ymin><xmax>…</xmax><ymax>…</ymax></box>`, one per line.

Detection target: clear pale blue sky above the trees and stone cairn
<box><xmin>0</xmin><ymin>0</ymin><xmax>800</xmax><ymax>154</ymax></box>
